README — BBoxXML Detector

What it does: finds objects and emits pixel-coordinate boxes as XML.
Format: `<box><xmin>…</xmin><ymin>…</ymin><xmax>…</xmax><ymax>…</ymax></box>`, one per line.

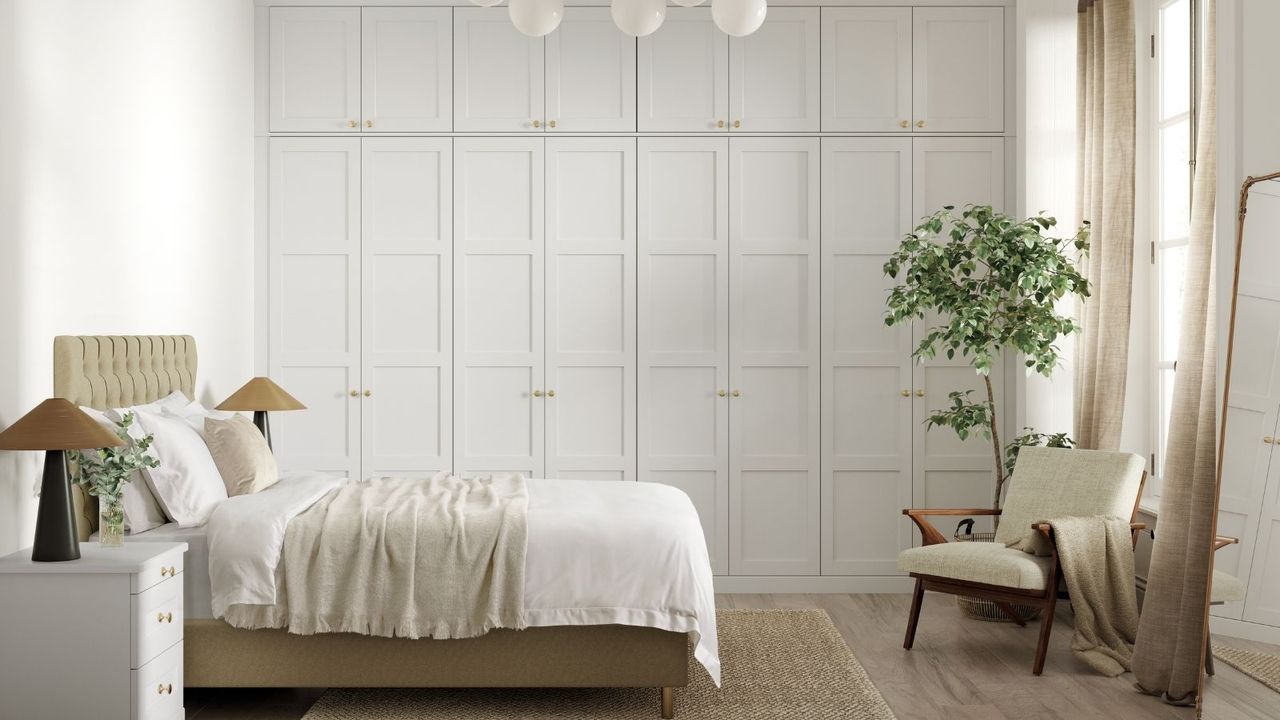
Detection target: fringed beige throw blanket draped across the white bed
<box><xmin>223</xmin><ymin>473</ymin><xmax>529</xmax><ymax>639</ymax></box>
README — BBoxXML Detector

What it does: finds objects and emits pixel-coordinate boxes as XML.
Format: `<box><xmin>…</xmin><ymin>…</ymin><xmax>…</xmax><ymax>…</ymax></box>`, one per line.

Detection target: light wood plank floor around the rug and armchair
<box><xmin>186</xmin><ymin>593</ymin><xmax>1280</xmax><ymax>720</ymax></box>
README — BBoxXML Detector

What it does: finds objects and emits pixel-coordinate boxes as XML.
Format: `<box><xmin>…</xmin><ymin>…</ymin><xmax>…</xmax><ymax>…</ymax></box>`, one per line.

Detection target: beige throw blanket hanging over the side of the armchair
<box><xmin>1048</xmin><ymin>516</ymin><xmax>1138</xmax><ymax>676</ymax></box>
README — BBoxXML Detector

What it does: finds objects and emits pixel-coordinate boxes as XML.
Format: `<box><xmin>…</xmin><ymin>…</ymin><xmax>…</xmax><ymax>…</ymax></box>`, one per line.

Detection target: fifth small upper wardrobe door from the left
<box><xmin>636</xmin><ymin>8</ymin><xmax>728</xmax><ymax>132</ymax></box>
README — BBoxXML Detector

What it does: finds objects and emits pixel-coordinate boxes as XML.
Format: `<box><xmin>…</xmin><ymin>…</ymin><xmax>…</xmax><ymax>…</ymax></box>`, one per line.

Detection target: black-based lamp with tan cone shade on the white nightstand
<box><xmin>0</xmin><ymin>397</ymin><xmax>124</xmax><ymax>562</ymax></box>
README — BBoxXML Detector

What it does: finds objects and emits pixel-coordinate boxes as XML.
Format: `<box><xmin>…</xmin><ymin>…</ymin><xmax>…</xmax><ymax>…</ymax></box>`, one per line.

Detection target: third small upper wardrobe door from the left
<box><xmin>453</xmin><ymin>6</ymin><xmax>544</xmax><ymax>132</ymax></box>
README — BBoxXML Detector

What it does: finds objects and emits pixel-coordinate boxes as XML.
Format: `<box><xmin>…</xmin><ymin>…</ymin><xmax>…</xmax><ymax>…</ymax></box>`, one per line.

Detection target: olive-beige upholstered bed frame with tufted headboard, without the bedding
<box><xmin>54</xmin><ymin>336</ymin><xmax>689</xmax><ymax>717</ymax></box>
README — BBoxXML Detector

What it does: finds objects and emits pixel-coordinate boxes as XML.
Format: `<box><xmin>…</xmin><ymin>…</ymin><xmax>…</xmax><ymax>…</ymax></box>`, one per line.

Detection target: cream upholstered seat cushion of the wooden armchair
<box><xmin>897</xmin><ymin>542</ymin><xmax>1050</xmax><ymax>591</ymax></box>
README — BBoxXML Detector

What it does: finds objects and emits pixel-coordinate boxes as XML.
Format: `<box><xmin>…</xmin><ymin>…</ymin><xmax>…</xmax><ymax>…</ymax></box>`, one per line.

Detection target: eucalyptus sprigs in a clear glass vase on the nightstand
<box><xmin>67</xmin><ymin>413</ymin><xmax>160</xmax><ymax>547</ymax></box>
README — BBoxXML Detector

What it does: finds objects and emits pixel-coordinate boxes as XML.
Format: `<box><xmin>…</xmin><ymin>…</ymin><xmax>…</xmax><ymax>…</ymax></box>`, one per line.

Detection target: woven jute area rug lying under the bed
<box><xmin>303</xmin><ymin>610</ymin><xmax>893</xmax><ymax>720</ymax></box>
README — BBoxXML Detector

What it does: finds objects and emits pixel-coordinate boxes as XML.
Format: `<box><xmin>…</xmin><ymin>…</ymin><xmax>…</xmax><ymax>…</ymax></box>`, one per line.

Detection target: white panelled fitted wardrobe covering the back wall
<box><xmin>257</xmin><ymin>3</ymin><xmax>1012</xmax><ymax>591</ymax></box>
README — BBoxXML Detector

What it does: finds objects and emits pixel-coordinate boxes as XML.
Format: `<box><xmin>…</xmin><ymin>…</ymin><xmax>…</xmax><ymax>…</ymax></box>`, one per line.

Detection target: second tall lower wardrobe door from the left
<box><xmin>361</xmin><ymin>137</ymin><xmax>453</xmax><ymax>478</ymax></box>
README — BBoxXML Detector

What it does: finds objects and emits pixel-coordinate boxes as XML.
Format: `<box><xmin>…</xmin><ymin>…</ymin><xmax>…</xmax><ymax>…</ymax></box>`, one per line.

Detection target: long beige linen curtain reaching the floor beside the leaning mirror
<box><xmin>1133</xmin><ymin>0</ymin><xmax>1217</xmax><ymax>705</ymax></box>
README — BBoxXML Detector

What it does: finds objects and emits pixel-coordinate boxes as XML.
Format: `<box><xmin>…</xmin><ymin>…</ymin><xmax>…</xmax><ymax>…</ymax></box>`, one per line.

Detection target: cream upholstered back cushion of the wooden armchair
<box><xmin>996</xmin><ymin>447</ymin><xmax>1146</xmax><ymax>555</ymax></box>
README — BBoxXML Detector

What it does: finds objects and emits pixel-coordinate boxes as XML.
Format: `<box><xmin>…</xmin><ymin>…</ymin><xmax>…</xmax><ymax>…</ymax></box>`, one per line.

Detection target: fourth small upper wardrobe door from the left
<box><xmin>547</xmin><ymin>8</ymin><xmax>636</xmax><ymax>132</ymax></box>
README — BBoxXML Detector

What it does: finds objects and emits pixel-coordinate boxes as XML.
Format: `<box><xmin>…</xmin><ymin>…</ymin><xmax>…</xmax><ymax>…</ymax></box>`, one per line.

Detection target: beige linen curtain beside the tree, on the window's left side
<box><xmin>1073</xmin><ymin>0</ymin><xmax>1137</xmax><ymax>450</ymax></box>
